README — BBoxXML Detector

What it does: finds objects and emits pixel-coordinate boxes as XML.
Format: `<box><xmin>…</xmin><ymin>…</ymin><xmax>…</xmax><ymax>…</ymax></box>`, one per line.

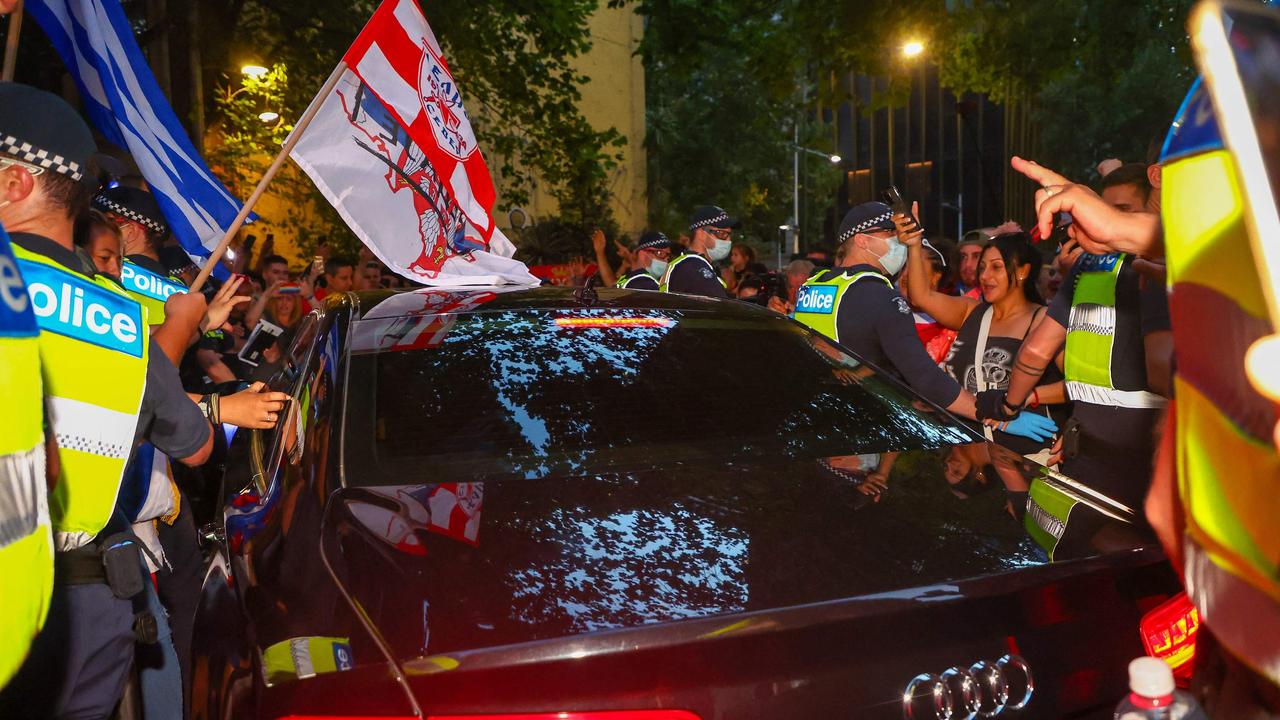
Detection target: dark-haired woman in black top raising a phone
<box><xmin>895</xmin><ymin>215</ymin><xmax>1068</xmax><ymax>458</ymax></box>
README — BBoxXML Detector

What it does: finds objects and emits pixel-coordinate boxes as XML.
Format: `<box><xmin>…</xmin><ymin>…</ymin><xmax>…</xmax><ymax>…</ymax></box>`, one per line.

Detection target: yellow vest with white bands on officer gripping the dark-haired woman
<box><xmin>1064</xmin><ymin>252</ymin><xmax>1167</xmax><ymax>407</ymax></box>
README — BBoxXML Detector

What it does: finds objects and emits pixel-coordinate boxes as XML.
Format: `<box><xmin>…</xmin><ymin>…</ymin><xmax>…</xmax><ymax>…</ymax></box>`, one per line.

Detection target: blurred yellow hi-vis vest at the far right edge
<box><xmin>1162</xmin><ymin>150</ymin><xmax>1280</xmax><ymax>684</ymax></box>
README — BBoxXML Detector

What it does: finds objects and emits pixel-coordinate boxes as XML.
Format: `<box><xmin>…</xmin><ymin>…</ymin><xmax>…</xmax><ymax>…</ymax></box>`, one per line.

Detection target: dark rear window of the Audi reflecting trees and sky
<box><xmin>344</xmin><ymin>302</ymin><xmax>979</xmax><ymax>486</ymax></box>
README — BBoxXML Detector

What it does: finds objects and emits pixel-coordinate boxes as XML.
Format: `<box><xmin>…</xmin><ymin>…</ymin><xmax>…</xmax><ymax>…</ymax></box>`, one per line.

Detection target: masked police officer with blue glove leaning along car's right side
<box><xmin>794</xmin><ymin>202</ymin><xmax>1057</xmax><ymax>441</ymax></box>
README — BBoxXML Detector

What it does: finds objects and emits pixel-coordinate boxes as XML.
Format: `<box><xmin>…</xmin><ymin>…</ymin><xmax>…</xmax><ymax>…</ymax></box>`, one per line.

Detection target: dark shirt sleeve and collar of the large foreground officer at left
<box><xmin>9</xmin><ymin>233</ymin><xmax>212</xmax><ymax>457</ymax></box>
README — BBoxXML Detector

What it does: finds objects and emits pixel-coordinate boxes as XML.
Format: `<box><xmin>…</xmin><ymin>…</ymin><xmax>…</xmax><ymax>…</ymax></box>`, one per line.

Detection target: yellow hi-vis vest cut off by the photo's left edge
<box><xmin>0</xmin><ymin>229</ymin><xmax>54</xmax><ymax>688</ymax></box>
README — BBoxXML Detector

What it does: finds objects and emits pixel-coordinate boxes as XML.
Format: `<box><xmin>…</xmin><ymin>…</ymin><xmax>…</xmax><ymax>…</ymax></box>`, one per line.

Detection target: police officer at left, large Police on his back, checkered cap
<box><xmin>0</xmin><ymin>83</ymin><xmax>212</xmax><ymax>717</ymax></box>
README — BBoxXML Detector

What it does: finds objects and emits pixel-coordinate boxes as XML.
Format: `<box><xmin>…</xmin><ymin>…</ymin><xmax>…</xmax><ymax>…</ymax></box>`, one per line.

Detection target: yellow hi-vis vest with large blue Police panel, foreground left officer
<box><xmin>14</xmin><ymin>245</ymin><xmax>150</xmax><ymax>551</ymax></box>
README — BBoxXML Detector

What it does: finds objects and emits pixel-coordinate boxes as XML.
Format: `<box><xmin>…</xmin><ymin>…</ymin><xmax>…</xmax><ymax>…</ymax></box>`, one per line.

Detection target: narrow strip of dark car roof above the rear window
<box><xmin>326</xmin><ymin>286</ymin><xmax>773</xmax><ymax>320</ymax></box>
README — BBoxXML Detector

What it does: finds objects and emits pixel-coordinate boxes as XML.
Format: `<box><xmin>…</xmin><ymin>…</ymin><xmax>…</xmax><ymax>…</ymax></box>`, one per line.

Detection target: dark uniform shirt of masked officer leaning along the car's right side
<box><xmin>819</xmin><ymin>265</ymin><xmax>960</xmax><ymax>407</ymax></box>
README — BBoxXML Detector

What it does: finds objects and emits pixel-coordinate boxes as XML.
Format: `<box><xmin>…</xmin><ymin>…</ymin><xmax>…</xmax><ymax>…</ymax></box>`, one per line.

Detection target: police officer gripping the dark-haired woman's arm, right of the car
<box><xmin>978</xmin><ymin>169</ymin><xmax>1171</xmax><ymax>559</ymax></box>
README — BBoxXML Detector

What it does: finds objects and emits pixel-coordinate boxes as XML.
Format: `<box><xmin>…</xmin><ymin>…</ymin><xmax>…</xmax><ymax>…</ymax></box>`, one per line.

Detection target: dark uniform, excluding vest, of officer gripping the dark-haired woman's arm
<box><xmin>1048</xmin><ymin>256</ymin><xmax>1172</xmax><ymax>511</ymax></box>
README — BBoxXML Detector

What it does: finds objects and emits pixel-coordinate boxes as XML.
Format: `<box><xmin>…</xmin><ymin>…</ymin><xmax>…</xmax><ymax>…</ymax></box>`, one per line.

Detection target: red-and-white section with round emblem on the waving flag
<box><xmin>343</xmin><ymin>0</ymin><xmax>495</xmax><ymax>242</ymax></box>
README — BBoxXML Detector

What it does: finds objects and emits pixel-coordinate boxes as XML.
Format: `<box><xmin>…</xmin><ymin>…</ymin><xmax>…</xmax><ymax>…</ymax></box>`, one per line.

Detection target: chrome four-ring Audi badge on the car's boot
<box><xmin>902</xmin><ymin>655</ymin><xmax>1036</xmax><ymax>720</ymax></box>
